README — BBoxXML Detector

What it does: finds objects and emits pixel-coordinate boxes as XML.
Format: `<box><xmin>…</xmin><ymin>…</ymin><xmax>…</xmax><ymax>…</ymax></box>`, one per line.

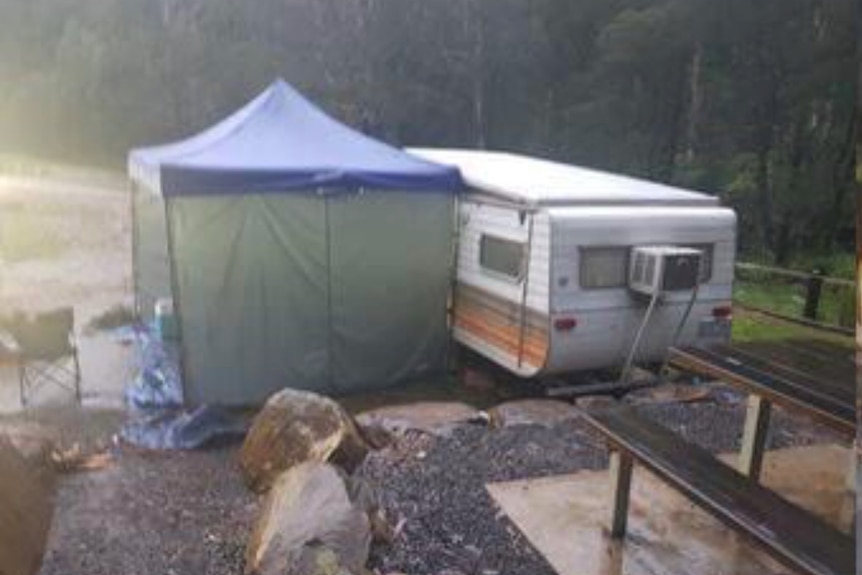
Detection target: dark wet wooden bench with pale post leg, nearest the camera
<box><xmin>586</xmin><ymin>407</ymin><xmax>854</xmax><ymax>575</ymax></box>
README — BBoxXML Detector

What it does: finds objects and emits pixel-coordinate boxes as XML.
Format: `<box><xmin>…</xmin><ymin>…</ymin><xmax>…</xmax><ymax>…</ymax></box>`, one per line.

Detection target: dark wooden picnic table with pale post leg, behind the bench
<box><xmin>670</xmin><ymin>340</ymin><xmax>856</xmax><ymax>486</ymax></box>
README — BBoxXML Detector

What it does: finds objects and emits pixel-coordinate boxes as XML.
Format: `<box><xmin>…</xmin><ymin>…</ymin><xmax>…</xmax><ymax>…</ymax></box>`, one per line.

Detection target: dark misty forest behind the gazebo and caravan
<box><xmin>0</xmin><ymin>0</ymin><xmax>859</xmax><ymax>264</ymax></box>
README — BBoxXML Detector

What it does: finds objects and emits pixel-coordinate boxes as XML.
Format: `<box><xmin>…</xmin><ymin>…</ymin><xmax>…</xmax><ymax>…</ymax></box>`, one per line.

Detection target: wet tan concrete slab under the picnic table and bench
<box><xmin>487</xmin><ymin>445</ymin><xmax>854</xmax><ymax>575</ymax></box>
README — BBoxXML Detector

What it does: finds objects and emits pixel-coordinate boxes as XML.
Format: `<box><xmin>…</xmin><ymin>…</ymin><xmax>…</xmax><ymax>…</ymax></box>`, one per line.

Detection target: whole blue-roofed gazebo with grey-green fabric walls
<box><xmin>129</xmin><ymin>80</ymin><xmax>461</xmax><ymax>405</ymax></box>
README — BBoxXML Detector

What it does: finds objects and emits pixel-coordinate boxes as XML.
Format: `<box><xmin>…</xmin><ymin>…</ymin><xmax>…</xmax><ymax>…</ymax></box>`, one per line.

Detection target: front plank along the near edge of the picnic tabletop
<box><xmin>668</xmin><ymin>348</ymin><xmax>856</xmax><ymax>437</ymax></box>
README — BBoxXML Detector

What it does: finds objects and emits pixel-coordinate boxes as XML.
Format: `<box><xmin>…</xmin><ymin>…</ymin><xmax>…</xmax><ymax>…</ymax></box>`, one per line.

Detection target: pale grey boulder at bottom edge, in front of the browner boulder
<box><xmin>245</xmin><ymin>462</ymin><xmax>371</xmax><ymax>575</ymax></box>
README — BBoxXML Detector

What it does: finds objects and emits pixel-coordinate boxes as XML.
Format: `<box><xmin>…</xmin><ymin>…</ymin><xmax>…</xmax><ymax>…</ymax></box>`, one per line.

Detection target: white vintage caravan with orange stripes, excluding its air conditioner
<box><xmin>411</xmin><ymin>149</ymin><xmax>736</xmax><ymax>377</ymax></box>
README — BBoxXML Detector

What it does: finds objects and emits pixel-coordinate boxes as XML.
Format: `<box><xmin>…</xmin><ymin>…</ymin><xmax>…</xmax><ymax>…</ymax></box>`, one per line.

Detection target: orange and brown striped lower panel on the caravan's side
<box><xmin>454</xmin><ymin>284</ymin><xmax>549</xmax><ymax>367</ymax></box>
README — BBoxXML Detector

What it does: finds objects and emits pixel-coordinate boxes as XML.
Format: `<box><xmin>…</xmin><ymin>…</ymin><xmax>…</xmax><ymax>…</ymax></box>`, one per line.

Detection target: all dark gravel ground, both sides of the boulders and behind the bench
<box><xmin>32</xmin><ymin>393</ymin><xmax>834</xmax><ymax>575</ymax></box>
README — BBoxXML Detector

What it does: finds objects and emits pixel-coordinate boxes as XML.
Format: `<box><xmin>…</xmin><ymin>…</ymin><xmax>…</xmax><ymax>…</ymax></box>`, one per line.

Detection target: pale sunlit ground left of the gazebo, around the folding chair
<box><xmin>0</xmin><ymin>171</ymin><xmax>132</xmax><ymax>413</ymax></box>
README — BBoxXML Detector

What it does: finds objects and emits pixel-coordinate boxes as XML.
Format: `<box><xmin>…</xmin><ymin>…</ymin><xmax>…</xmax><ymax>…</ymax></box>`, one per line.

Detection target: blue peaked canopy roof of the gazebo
<box><xmin>129</xmin><ymin>80</ymin><xmax>461</xmax><ymax>197</ymax></box>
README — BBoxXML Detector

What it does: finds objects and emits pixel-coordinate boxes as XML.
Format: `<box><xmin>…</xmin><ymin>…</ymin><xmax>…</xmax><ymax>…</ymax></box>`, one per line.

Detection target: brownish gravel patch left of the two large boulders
<box><xmin>41</xmin><ymin>448</ymin><xmax>256</xmax><ymax>575</ymax></box>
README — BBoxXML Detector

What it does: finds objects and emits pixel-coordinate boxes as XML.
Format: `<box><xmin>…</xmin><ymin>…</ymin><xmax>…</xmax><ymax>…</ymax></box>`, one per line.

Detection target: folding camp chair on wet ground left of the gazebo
<box><xmin>9</xmin><ymin>307</ymin><xmax>81</xmax><ymax>407</ymax></box>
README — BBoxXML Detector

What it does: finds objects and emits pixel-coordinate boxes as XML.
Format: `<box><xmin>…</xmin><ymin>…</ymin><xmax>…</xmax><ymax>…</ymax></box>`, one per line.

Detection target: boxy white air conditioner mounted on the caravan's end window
<box><xmin>629</xmin><ymin>246</ymin><xmax>703</xmax><ymax>296</ymax></box>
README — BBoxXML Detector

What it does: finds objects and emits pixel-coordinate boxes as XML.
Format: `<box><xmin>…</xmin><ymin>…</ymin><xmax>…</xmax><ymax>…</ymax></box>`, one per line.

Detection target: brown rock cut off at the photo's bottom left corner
<box><xmin>0</xmin><ymin>438</ymin><xmax>53</xmax><ymax>575</ymax></box>
